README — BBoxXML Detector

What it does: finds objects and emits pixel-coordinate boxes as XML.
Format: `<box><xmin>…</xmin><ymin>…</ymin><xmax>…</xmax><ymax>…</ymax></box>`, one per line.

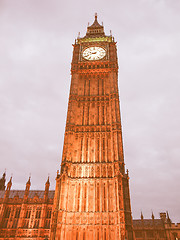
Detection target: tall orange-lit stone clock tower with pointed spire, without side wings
<box><xmin>50</xmin><ymin>15</ymin><xmax>133</xmax><ymax>240</ymax></box>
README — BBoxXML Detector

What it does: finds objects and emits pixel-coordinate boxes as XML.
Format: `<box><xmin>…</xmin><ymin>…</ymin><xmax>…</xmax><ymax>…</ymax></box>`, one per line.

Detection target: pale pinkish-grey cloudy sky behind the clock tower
<box><xmin>0</xmin><ymin>0</ymin><xmax>180</xmax><ymax>222</ymax></box>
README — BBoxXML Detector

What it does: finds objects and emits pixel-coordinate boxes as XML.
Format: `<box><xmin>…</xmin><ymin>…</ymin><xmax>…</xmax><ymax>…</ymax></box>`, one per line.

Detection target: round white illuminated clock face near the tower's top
<box><xmin>82</xmin><ymin>47</ymin><xmax>106</xmax><ymax>61</ymax></box>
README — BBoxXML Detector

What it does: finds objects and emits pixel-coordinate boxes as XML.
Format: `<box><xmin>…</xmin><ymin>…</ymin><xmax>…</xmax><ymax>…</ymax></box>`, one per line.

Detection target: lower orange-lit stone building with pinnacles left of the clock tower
<box><xmin>0</xmin><ymin>175</ymin><xmax>54</xmax><ymax>239</ymax></box>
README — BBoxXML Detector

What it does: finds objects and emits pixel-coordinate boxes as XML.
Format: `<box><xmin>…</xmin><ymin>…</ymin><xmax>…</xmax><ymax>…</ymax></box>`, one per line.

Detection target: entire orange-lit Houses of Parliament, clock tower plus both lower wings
<box><xmin>0</xmin><ymin>15</ymin><xmax>180</xmax><ymax>240</ymax></box>
